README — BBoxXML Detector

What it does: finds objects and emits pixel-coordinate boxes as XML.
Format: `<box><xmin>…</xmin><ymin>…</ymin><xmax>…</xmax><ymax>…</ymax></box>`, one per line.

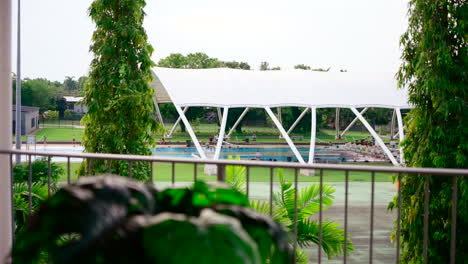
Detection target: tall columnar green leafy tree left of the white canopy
<box><xmin>81</xmin><ymin>0</ymin><xmax>160</xmax><ymax>180</ymax></box>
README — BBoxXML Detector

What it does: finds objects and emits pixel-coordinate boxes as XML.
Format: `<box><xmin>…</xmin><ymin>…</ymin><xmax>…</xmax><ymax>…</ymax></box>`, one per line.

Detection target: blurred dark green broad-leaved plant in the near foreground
<box><xmin>12</xmin><ymin>176</ymin><xmax>292</xmax><ymax>264</ymax></box>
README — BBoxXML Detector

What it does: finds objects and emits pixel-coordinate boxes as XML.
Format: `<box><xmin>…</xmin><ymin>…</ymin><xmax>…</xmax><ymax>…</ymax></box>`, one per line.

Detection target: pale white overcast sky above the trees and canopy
<box><xmin>12</xmin><ymin>0</ymin><xmax>407</xmax><ymax>81</ymax></box>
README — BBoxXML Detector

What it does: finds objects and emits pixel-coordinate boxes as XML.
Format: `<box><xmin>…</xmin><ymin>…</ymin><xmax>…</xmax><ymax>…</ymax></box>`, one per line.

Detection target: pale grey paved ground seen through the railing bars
<box><xmin>156</xmin><ymin>182</ymin><xmax>396</xmax><ymax>263</ymax></box>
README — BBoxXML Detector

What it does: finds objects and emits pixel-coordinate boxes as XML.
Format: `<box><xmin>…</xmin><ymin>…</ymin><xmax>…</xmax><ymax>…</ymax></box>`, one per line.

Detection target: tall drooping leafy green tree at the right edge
<box><xmin>389</xmin><ymin>0</ymin><xmax>468</xmax><ymax>263</ymax></box>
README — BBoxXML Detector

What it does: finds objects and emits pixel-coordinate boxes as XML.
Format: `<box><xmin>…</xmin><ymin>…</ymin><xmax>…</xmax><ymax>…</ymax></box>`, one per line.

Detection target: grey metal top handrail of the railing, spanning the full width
<box><xmin>0</xmin><ymin>149</ymin><xmax>468</xmax><ymax>176</ymax></box>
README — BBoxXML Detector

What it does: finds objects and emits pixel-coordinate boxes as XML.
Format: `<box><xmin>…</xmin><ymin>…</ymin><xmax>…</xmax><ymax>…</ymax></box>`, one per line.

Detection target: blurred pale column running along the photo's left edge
<box><xmin>0</xmin><ymin>0</ymin><xmax>13</xmax><ymax>262</ymax></box>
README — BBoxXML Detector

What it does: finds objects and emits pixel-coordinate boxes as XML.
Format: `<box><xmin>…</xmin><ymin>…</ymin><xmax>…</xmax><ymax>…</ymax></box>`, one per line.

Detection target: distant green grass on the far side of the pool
<box><xmin>27</xmin><ymin>124</ymin><xmax>388</xmax><ymax>144</ymax></box>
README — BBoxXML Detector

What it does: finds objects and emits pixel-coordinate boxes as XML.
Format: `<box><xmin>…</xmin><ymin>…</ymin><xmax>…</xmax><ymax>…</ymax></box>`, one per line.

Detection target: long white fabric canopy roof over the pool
<box><xmin>152</xmin><ymin>68</ymin><xmax>410</xmax><ymax>108</ymax></box>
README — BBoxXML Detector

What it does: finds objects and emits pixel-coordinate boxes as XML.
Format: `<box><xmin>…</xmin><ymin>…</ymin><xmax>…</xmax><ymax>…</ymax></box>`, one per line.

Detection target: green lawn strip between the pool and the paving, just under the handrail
<box><xmin>58</xmin><ymin>163</ymin><xmax>392</xmax><ymax>182</ymax></box>
